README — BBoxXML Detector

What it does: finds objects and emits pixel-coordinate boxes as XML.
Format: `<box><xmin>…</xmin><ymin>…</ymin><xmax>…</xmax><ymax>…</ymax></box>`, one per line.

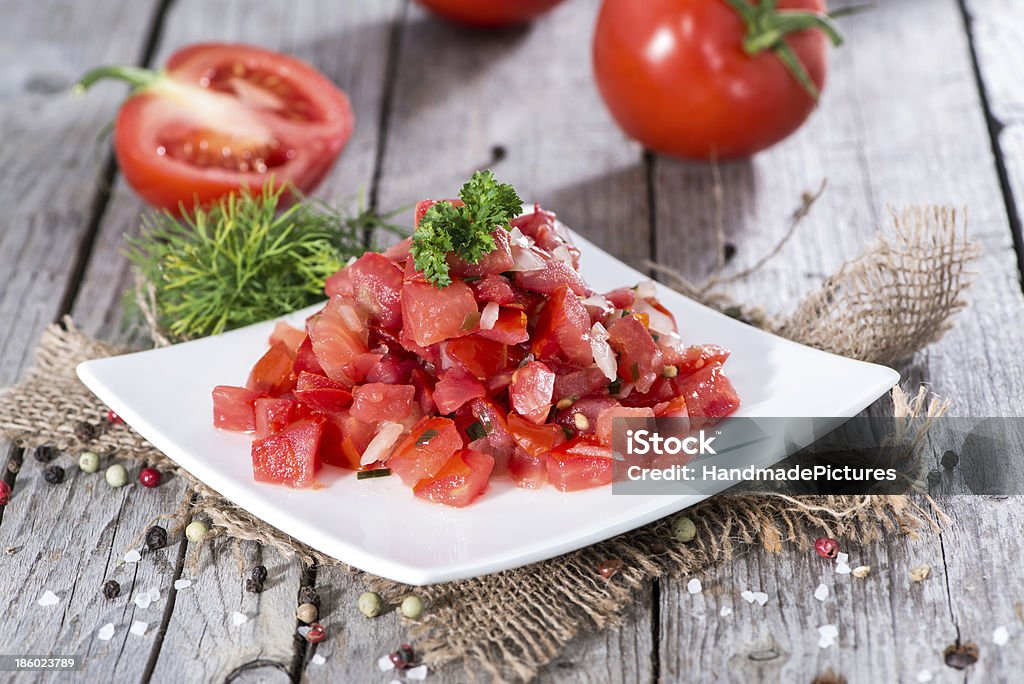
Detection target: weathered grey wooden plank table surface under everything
<box><xmin>0</xmin><ymin>0</ymin><xmax>1024</xmax><ymax>682</ymax></box>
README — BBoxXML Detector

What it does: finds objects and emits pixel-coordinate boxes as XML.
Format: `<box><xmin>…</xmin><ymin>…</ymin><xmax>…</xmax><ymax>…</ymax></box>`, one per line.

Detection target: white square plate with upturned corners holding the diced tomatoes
<box><xmin>78</xmin><ymin>228</ymin><xmax>899</xmax><ymax>585</ymax></box>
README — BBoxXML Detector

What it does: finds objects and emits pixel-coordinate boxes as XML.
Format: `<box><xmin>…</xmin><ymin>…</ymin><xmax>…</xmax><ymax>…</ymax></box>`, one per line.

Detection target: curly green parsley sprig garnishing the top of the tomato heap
<box><xmin>412</xmin><ymin>171</ymin><xmax>522</xmax><ymax>288</ymax></box>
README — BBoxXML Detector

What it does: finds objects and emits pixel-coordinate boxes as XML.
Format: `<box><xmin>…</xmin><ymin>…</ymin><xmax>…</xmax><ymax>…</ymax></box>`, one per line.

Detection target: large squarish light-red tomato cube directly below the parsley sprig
<box><xmin>401</xmin><ymin>281</ymin><xmax>480</xmax><ymax>347</ymax></box>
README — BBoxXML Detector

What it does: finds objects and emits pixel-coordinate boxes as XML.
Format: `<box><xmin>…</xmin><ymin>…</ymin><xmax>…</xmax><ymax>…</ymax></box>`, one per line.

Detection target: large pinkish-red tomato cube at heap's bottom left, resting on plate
<box><xmin>252</xmin><ymin>418</ymin><xmax>324</xmax><ymax>487</ymax></box>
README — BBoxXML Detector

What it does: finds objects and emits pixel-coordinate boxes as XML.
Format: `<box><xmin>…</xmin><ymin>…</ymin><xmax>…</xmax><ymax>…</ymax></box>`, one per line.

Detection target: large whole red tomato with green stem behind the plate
<box><xmin>593</xmin><ymin>0</ymin><xmax>841</xmax><ymax>160</ymax></box>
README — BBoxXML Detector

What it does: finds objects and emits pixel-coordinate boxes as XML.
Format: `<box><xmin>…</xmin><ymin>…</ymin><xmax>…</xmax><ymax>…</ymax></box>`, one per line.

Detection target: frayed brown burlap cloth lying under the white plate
<box><xmin>0</xmin><ymin>205</ymin><xmax>976</xmax><ymax>680</ymax></box>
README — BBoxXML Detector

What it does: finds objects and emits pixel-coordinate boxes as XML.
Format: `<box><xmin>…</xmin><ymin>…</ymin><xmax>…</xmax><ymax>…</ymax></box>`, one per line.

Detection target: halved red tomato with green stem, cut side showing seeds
<box><xmin>79</xmin><ymin>43</ymin><xmax>354</xmax><ymax>211</ymax></box>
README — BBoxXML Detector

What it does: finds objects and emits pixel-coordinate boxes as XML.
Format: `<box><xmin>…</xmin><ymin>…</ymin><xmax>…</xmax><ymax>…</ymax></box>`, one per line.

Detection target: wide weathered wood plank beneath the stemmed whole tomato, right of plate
<box><xmin>655</xmin><ymin>1</ymin><xmax>1024</xmax><ymax>681</ymax></box>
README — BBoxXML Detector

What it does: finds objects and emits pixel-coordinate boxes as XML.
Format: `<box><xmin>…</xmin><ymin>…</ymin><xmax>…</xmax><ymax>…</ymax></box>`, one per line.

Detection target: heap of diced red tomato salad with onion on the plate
<box><xmin>213</xmin><ymin>188</ymin><xmax>739</xmax><ymax>506</ymax></box>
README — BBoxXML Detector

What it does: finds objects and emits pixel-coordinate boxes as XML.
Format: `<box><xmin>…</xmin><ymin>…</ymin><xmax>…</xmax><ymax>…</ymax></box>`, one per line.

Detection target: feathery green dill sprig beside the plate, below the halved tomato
<box><xmin>126</xmin><ymin>183</ymin><xmax>403</xmax><ymax>341</ymax></box>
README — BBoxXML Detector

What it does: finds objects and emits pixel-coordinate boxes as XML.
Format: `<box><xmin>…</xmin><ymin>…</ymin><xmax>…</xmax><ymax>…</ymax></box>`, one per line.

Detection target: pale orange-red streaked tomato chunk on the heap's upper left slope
<box><xmin>310</xmin><ymin>295</ymin><xmax>369</xmax><ymax>386</ymax></box>
